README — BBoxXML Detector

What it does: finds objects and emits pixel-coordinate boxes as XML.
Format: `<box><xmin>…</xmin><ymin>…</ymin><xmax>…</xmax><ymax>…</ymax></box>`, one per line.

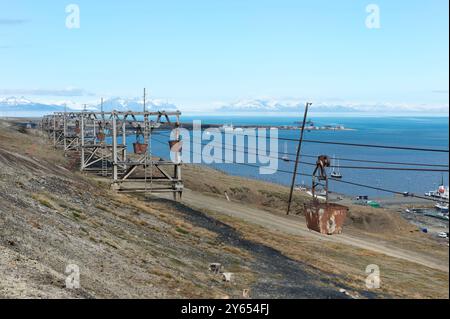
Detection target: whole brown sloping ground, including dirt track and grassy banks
<box><xmin>0</xmin><ymin>120</ymin><xmax>448</xmax><ymax>298</ymax></box>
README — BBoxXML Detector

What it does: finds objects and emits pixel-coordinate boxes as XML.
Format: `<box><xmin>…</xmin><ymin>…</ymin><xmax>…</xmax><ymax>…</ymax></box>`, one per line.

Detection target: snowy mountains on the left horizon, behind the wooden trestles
<box><xmin>0</xmin><ymin>97</ymin><xmax>177</xmax><ymax>116</ymax></box>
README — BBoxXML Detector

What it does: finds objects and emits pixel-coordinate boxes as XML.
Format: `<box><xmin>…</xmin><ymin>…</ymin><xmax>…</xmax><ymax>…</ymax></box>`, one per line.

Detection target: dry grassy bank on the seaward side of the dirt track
<box><xmin>183</xmin><ymin>165</ymin><xmax>448</xmax><ymax>258</ymax></box>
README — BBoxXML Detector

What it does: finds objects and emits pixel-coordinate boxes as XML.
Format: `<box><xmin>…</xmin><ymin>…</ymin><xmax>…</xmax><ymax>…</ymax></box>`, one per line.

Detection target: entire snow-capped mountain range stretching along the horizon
<box><xmin>0</xmin><ymin>97</ymin><xmax>449</xmax><ymax>116</ymax></box>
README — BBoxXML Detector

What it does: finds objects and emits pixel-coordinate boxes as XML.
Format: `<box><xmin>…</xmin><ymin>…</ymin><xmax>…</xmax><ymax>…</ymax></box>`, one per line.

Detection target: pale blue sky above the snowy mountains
<box><xmin>0</xmin><ymin>0</ymin><xmax>449</xmax><ymax>110</ymax></box>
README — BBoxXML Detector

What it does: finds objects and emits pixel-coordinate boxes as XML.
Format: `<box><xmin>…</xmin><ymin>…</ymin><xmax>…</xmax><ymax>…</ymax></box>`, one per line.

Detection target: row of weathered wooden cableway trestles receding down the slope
<box><xmin>41</xmin><ymin>111</ymin><xmax>184</xmax><ymax>199</ymax></box>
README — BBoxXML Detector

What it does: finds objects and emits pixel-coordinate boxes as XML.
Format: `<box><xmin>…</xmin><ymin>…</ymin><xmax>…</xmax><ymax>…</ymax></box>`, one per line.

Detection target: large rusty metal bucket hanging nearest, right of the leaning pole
<box><xmin>305</xmin><ymin>202</ymin><xmax>348</xmax><ymax>235</ymax></box>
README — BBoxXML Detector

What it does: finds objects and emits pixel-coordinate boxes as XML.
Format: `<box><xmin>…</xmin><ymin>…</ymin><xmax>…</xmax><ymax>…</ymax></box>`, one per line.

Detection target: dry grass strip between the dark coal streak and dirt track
<box><xmin>210</xmin><ymin>213</ymin><xmax>449</xmax><ymax>299</ymax></box>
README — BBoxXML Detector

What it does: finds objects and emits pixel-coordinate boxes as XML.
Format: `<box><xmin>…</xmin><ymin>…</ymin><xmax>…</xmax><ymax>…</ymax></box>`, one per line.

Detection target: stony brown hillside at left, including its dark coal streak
<box><xmin>0</xmin><ymin>121</ymin><xmax>370</xmax><ymax>298</ymax></box>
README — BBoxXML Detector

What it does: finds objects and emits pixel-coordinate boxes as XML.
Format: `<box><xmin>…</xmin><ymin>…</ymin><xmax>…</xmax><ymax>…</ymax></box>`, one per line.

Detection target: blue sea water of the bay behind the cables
<box><xmin>128</xmin><ymin>116</ymin><xmax>449</xmax><ymax>197</ymax></box>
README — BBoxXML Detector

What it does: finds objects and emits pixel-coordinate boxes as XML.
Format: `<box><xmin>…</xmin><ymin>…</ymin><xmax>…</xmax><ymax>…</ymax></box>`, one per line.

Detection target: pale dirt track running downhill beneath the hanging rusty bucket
<box><xmin>160</xmin><ymin>190</ymin><xmax>449</xmax><ymax>273</ymax></box>
